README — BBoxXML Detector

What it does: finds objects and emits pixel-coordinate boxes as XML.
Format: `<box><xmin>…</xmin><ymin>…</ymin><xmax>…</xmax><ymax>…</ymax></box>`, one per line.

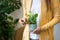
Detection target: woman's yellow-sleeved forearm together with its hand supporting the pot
<box><xmin>33</xmin><ymin>15</ymin><xmax>60</xmax><ymax>34</ymax></box>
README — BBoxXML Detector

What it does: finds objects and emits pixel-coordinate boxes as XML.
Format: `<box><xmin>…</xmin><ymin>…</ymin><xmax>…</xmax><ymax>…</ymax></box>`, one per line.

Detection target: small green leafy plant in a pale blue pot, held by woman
<box><xmin>28</xmin><ymin>12</ymin><xmax>38</xmax><ymax>31</ymax></box>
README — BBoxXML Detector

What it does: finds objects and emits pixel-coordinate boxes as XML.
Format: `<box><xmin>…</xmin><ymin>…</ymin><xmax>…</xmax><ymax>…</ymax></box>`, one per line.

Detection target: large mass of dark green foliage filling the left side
<box><xmin>0</xmin><ymin>0</ymin><xmax>21</xmax><ymax>40</ymax></box>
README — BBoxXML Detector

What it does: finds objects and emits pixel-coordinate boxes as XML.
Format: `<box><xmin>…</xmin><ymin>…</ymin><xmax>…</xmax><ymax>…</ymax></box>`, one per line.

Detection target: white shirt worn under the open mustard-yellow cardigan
<box><xmin>30</xmin><ymin>0</ymin><xmax>41</xmax><ymax>39</ymax></box>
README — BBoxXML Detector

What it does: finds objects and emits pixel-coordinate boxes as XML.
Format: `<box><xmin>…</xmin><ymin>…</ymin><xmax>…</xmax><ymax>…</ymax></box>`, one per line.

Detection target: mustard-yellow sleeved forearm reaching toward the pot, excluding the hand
<box><xmin>41</xmin><ymin>16</ymin><xmax>60</xmax><ymax>31</ymax></box>
